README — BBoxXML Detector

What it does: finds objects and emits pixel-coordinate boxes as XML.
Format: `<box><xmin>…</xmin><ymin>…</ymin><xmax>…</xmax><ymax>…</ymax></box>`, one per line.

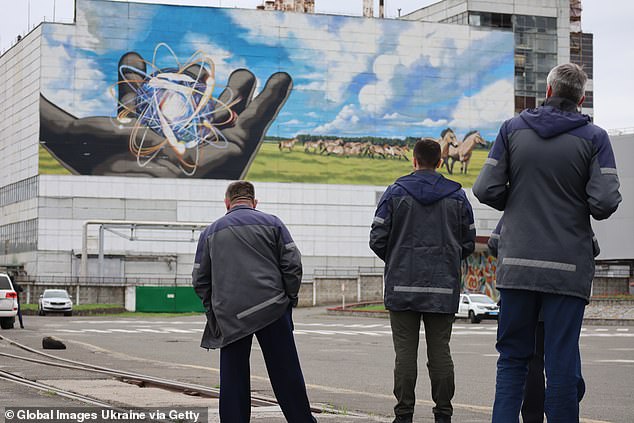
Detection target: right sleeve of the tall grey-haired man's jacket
<box><xmin>586</xmin><ymin>130</ymin><xmax>621</xmax><ymax>220</ymax></box>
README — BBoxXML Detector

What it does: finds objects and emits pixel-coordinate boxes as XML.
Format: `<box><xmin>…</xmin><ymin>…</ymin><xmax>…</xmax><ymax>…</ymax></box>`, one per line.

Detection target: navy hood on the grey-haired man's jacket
<box><xmin>520</xmin><ymin>97</ymin><xmax>590</xmax><ymax>138</ymax></box>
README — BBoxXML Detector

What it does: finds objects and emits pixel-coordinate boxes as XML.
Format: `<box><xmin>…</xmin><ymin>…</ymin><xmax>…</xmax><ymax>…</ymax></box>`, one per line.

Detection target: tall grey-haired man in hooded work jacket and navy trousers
<box><xmin>473</xmin><ymin>63</ymin><xmax>621</xmax><ymax>423</ymax></box>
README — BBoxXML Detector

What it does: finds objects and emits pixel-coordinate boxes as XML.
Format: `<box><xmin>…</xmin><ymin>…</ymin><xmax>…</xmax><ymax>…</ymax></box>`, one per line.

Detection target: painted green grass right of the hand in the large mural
<box><xmin>247</xmin><ymin>142</ymin><xmax>488</xmax><ymax>187</ymax></box>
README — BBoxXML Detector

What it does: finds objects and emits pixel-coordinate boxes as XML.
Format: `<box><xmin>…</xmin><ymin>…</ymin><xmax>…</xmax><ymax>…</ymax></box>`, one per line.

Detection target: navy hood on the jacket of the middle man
<box><xmin>395</xmin><ymin>170</ymin><xmax>462</xmax><ymax>205</ymax></box>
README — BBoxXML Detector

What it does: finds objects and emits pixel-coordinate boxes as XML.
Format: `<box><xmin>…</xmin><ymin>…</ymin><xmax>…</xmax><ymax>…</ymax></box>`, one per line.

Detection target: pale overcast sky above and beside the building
<box><xmin>0</xmin><ymin>0</ymin><xmax>634</xmax><ymax>129</ymax></box>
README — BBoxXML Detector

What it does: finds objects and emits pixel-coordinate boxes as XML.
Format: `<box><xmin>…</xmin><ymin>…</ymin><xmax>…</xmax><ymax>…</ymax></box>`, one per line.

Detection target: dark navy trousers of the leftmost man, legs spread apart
<box><xmin>220</xmin><ymin>308</ymin><xmax>315</xmax><ymax>423</ymax></box>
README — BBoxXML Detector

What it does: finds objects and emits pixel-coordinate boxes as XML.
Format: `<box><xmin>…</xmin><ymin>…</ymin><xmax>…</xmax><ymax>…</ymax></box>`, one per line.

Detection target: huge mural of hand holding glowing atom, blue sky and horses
<box><xmin>40</xmin><ymin>0</ymin><xmax>513</xmax><ymax>185</ymax></box>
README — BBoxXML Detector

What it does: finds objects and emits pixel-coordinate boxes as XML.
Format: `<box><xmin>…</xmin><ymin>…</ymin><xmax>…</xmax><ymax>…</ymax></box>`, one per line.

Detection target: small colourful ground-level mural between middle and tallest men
<box><xmin>461</xmin><ymin>252</ymin><xmax>499</xmax><ymax>301</ymax></box>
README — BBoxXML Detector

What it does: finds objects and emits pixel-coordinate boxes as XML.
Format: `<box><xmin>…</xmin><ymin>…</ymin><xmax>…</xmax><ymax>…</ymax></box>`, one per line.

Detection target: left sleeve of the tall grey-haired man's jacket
<box><xmin>473</xmin><ymin>121</ymin><xmax>509</xmax><ymax>210</ymax></box>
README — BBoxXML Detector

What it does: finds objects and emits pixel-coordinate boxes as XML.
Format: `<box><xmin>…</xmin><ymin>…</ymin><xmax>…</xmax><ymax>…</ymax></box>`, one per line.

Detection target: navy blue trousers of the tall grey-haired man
<box><xmin>493</xmin><ymin>289</ymin><xmax>586</xmax><ymax>423</ymax></box>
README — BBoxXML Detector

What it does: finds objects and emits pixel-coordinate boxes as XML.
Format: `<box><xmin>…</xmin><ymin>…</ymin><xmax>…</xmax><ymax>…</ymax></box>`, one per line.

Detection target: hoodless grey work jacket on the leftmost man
<box><xmin>192</xmin><ymin>206</ymin><xmax>302</xmax><ymax>348</ymax></box>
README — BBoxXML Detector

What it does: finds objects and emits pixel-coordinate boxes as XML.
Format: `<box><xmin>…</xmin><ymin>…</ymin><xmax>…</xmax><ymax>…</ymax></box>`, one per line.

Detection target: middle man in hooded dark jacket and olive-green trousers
<box><xmin>370</xmin><ymin>139</ymin><xmax>475</xmax><ymax>423</ymax></box>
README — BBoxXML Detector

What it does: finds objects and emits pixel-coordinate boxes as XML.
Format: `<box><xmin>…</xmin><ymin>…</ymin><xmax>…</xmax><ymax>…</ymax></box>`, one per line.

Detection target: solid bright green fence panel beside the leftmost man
<box><xmin>136</xmin><ymin>286</ymin><xmax>205</xmax><ymax>313</ymax></box>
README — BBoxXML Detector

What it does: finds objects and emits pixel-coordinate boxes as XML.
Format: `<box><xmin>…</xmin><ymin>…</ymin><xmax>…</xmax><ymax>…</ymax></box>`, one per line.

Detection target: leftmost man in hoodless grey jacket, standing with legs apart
<box><xmin>192</xmin><ymin>181</ymin><xmax>316</xmax><ymax>423</ymax></box>
